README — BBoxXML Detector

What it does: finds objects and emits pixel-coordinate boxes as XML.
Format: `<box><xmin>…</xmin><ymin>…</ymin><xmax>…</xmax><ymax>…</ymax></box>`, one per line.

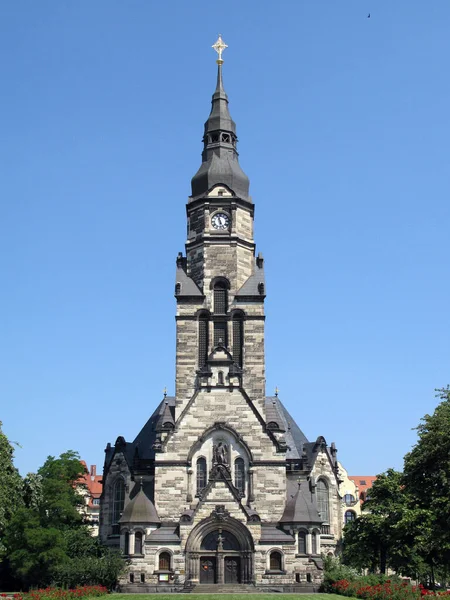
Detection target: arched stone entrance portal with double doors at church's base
<box><xmin>186</xmin><ymin>507</ymin><xmax>253</xmax><ymax>584</ymax></box>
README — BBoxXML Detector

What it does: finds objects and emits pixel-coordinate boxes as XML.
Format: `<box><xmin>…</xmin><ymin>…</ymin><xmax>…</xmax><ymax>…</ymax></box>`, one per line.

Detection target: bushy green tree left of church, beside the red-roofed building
<box><xmin>5</xmin><ymin>451</ymin><xmax>125</xmax><ymax>588</ymax></box>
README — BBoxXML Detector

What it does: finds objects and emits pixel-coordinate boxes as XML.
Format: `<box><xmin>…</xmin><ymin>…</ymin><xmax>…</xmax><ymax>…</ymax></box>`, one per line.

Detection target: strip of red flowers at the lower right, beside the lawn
<box><xmin>332</xmin><ymin>579</ymin><xmax>450</xmax><ymax>600</ymax></box>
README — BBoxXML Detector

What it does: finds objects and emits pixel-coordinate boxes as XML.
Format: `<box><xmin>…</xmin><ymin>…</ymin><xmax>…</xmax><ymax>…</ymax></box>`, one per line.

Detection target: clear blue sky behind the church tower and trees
<box><xmin>0</xmin><ymin>0</ymin><xmax>450</xmax><ymax>475</ymax></box>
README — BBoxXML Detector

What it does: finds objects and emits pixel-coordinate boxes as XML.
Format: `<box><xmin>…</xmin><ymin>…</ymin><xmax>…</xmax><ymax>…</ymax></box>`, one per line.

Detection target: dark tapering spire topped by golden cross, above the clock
<box><xmin>192</xmin><ymin>34</ymin><xmax>249</xmax><ymax>200</ymax></box>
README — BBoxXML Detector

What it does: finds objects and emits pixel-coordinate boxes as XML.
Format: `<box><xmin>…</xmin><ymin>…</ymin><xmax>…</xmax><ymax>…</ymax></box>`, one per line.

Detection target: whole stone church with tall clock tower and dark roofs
<box><xmin>100</xmin><ymin>36</ymin><xmax>342</xmax><ymax>592</ymax></box>
